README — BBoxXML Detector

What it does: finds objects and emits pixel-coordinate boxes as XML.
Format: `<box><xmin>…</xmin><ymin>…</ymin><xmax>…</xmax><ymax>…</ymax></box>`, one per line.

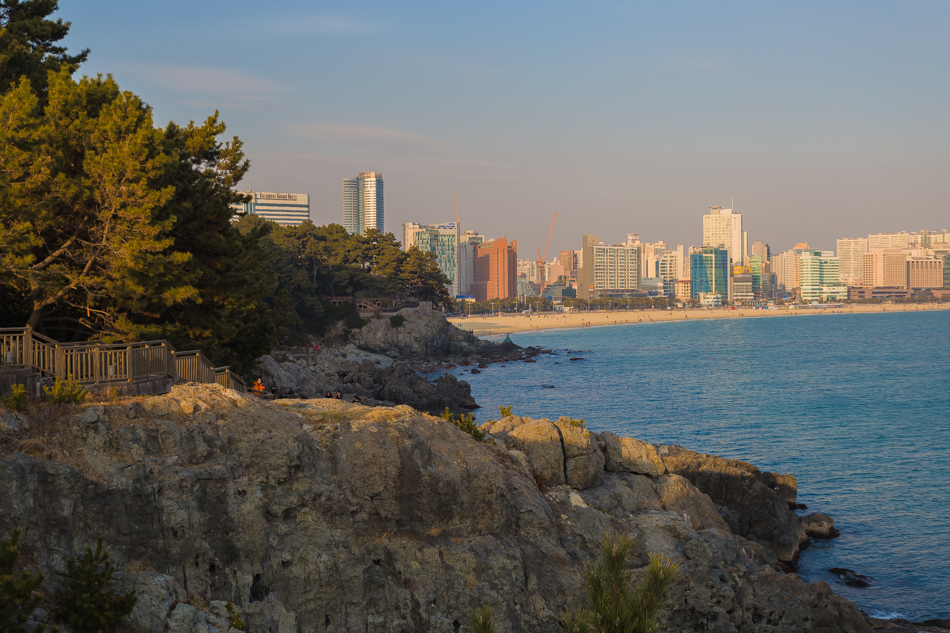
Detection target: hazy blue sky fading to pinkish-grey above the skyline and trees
<box><xmin>67</xmin><ymin>0</ymin><xmax>950</xmax><ymax>254</ymax></box>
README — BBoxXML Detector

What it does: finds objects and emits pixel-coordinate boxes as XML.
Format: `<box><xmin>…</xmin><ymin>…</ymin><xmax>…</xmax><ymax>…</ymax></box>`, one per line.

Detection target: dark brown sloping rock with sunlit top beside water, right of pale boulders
<box><xmin>657</xmin><ymin>445</ymin><xmax>805</xmax><ymax>562</ymax></box>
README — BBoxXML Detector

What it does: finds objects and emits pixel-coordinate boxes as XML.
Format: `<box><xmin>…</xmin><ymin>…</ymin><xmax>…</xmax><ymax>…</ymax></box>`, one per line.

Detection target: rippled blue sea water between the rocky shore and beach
<box><xmin>460</xmin><ymin>311</ymin><xmax>950</xmax><ymax>620</ymax></box>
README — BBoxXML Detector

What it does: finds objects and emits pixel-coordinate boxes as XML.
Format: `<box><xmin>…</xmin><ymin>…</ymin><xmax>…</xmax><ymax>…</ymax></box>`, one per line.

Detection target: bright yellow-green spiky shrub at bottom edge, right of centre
<box><xmin>560</xmin><ymin>535</ymin><xmax>679</xmax><ymax>633</ymax></box>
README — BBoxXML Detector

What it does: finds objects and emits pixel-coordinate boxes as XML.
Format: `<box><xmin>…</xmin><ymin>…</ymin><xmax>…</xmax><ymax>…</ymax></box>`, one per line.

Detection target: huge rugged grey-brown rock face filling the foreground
<box><xmin>0</xmin><ymin>385</ymin><xmax>868</xmax><ymax>633</ymax></box>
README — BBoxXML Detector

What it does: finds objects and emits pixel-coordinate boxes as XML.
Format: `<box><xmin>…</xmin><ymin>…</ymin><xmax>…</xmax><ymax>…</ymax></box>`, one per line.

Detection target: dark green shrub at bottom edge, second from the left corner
<box><xmin>55</xmin><ymin>536</ymin><xmax>135</xmax><ymax>633</ymax></box>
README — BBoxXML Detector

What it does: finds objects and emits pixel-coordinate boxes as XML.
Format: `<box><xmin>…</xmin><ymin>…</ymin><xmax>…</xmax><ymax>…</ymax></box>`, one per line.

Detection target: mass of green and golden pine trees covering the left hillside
<box><xmin>0</xmin><ymin>0</ymin><xmax>458</xmax><ymax>371</ymax></box>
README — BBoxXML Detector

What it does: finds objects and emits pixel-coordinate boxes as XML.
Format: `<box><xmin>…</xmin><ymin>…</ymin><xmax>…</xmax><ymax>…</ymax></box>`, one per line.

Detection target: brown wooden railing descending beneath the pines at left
<box><xmin>0</xmin><ymin>328</ymin><xmax>247</xmax><ymax>391</ymax></box>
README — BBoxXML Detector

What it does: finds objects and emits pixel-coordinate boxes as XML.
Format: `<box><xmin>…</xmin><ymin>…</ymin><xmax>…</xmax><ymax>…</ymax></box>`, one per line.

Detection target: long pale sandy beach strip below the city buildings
<box><xmin>449</xmin><ymin>303</ymin><xmax>950</xmax><ymax>336</ymax></box>
